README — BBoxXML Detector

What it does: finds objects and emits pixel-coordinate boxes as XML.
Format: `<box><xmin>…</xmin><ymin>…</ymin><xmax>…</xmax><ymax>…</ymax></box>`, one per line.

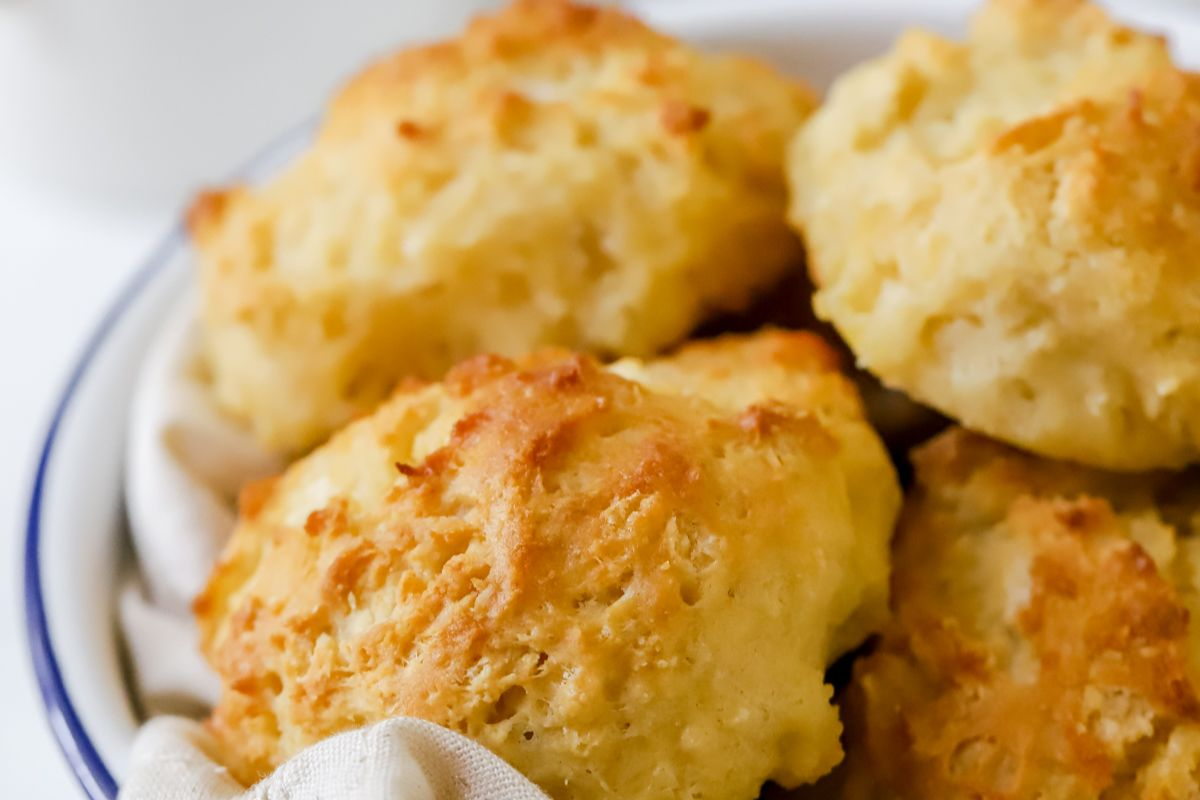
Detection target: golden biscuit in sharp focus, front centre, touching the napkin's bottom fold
<box><xmin>197</xmin><ymin>333</ymin><xmax>899</xmax><ymax>799</ymax></box>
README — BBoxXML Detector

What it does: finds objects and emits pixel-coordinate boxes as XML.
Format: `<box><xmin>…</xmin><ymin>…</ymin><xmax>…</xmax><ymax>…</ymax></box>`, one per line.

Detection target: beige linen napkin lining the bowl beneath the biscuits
<box><xmin>119</xmin><ymin>297</ymin><xmax>546</xmax><ymax>800</ymax></box>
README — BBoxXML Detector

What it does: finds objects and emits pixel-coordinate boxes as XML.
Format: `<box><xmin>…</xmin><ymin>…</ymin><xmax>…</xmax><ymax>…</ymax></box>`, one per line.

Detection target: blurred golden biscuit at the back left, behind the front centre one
<box><xmin>190</xmin><ymin>0</ymin><xmax>815</xmax><ymax>450</ymax></box>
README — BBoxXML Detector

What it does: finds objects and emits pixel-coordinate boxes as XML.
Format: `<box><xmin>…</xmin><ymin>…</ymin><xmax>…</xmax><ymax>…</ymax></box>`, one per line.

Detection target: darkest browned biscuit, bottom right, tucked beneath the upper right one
<box><xmin>828</xmin><ymin>428</ymin><xmax>1200</xmax><ymax>800</ymax></box>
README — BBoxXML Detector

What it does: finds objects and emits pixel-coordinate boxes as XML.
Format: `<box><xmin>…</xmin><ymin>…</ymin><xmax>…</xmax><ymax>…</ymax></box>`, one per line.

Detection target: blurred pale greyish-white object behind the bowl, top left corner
<box><xmin>0</xmin><ymin>0</ymin><xmax>488</xmax><ymax>204</ymax></box>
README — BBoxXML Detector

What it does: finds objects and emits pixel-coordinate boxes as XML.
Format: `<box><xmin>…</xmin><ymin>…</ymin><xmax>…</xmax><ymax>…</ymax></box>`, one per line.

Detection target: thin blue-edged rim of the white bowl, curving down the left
<box><xmin>23</xmin><ymin>119</ymin><xmax>314</xmax><ymax>800</ymax></box>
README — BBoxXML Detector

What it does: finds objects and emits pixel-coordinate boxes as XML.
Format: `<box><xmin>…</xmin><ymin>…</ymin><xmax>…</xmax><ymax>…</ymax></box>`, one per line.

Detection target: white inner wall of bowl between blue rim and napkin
<box><xmin>40</xmin><ymin>251</ymin><xmax>184</xmax><ymax>772</ymax></box>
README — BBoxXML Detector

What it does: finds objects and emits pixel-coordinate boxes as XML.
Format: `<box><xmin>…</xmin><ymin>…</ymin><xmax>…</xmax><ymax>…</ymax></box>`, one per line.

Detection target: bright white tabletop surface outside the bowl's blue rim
<box><xmin>0</xmin><ymin>0</ymin><xmax>1195</xmax><ymax>800</ymax></box>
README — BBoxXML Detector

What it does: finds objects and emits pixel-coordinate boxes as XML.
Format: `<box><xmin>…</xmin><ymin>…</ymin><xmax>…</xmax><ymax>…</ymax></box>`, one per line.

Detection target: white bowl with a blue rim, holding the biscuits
<box><xmin>25</xmin><ymin>0</ymin><xmax>1200</xmax><ymax>800</ymax></box>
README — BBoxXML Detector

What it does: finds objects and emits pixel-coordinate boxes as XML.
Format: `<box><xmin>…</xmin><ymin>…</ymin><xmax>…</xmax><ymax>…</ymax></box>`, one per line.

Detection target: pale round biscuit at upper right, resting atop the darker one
<box><xmin>790</xmin><ymin>0</ymin><xmax>1200</xmax><ymax>470</ymax></box>
